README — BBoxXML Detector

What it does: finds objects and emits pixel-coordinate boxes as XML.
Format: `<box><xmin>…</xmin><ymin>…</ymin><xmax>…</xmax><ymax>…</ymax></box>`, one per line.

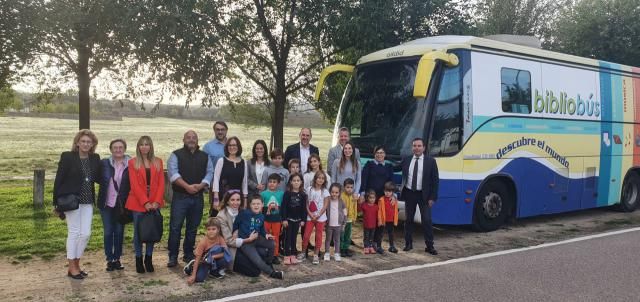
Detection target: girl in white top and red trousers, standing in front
<box><xmin>302</xmin><ymin>171</ymin><xmax>329</xmax><ymax>264</ymax></box>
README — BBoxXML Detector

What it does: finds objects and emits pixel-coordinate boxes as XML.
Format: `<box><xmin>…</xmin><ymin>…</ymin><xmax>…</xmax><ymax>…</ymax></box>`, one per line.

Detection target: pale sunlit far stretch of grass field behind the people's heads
<box><xmin>0</xmin><ymin>117</ymin><xmax>333</xmax><ymax>180</ymax></box>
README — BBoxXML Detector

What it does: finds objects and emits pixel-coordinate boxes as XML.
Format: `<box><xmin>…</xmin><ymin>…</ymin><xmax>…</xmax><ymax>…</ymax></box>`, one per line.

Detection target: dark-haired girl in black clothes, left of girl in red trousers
<box><xmin>280</xmin><ymin>172</ymin><xmax>307</xmax><ymax>264</ymax></box>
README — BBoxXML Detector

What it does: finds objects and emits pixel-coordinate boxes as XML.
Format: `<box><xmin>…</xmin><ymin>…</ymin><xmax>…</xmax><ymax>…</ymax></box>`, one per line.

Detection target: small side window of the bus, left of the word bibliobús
<box><xmin>500</xmin><ymin>68</ymin><xmax>531</xmax><ymax>114</ymax></box>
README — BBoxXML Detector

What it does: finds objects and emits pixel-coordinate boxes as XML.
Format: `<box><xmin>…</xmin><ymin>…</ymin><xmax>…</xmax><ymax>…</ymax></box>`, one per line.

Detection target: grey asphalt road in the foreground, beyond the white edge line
<box><xmin>218</xmin><ymin>230</ymin><xmax>640</xmax><ymax>302</ymax></box>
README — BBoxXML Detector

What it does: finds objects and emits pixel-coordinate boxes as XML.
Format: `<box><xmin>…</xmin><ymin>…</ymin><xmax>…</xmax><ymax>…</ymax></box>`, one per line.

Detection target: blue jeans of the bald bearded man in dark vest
<box><xmin>169</xmin><ymin>192</ymin><xmax>204</xmax><ymax>259</ymax></box>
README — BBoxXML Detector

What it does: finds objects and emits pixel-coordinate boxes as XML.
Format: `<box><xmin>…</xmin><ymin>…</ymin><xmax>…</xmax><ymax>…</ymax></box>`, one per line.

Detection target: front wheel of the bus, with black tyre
<box><xmin>473</xmin><ymin>180</ymin><xmax>512</xmax><ymax>232</ymax></box>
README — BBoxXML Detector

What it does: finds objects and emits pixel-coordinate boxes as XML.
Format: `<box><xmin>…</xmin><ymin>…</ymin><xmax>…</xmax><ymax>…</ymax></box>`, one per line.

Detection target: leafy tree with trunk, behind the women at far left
<box><xmin>33</xmin><ymin>0</ymin><xmax>131</xmax><ymax>129</ymax></box>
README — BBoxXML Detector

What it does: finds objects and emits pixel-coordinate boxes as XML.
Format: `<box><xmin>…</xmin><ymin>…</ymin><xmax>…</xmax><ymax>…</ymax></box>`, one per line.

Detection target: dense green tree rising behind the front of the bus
<box><xmin>313</xmin><ymin>0</ymin><xmax>472</xmax><ymax>123</ymax></box>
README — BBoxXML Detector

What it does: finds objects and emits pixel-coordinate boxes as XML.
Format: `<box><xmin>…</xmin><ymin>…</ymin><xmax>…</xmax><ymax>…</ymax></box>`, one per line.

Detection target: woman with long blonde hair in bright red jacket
<box><xmin>126</xmin><ymin>135</ymin><xmax>164</xmax><ymax>273</ymax></box>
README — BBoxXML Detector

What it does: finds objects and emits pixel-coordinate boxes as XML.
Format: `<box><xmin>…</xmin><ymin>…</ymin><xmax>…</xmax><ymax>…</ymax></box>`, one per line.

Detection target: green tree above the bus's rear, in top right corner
<box><xmin>548</xmin><ymin>0</ymin><xmax>640</xmax><ymax>66</ymax></box>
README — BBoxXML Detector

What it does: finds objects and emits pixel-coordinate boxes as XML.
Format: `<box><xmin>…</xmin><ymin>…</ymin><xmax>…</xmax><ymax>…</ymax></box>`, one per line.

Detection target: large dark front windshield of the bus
<box><xmin>338</xmin><ymin>57</ymin><xmax>428</xmax><ymax>158</ymax></box>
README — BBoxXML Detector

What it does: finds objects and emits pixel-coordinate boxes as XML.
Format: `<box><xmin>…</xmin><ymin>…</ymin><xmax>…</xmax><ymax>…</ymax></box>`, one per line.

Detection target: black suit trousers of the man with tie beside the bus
<box><xmin>402</xmin><ymin>188</ymin><xmax>433</xmax><ymax>247</ymax></box>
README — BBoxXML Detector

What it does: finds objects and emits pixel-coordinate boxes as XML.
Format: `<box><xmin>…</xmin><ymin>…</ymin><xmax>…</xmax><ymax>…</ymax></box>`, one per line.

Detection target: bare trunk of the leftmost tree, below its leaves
<box><xmin>76</xmin><ymin>46</ymin><xmax>91</xmax><ymax>129</ymax></box>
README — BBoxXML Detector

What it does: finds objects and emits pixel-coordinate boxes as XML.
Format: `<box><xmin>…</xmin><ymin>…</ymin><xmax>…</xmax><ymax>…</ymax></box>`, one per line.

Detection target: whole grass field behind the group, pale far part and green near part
<box><xmin>0</xmin><ymin>117</ymin><xmax>332</xmax><ymax>262</ymax></box>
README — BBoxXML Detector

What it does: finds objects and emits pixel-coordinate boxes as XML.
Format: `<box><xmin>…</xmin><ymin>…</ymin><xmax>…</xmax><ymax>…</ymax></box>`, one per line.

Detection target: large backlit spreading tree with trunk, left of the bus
<box><xmin>131</xmin><ymin>0</ymin><xmax>344</xmax><ymax>148</ymax></box>
